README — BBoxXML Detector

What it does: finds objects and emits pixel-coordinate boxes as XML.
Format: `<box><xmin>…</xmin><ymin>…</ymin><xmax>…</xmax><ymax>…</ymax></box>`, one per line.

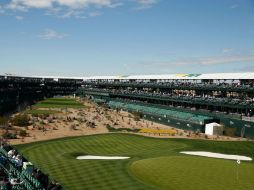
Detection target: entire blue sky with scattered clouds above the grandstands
<box><xmin>0</xmin><ymin>0</ymin><xmax>254</xmax><ymax>76</ymax></box>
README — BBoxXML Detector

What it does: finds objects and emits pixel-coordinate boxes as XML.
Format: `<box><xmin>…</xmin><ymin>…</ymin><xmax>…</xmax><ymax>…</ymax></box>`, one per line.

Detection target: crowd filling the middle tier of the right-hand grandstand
<box><xmin>84</xmin><ymin>87</ymin><xmax>254</xmax><ymax>117</ymax></box>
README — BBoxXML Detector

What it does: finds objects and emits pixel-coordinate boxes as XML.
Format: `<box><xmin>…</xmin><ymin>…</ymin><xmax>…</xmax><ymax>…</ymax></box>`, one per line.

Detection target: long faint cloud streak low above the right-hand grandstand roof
<box><xmin>145</xmin><ymin>55</ymin><xmax>254</xmax><ymax>67</ymax></box>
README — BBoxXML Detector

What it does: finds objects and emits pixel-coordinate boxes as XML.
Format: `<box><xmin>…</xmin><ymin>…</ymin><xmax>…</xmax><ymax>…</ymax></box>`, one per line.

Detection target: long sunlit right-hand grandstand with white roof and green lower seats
<box><xmin>78</xmin><ymin>73</ymin><xmax>254</xmax><ymax>138</ymax></box>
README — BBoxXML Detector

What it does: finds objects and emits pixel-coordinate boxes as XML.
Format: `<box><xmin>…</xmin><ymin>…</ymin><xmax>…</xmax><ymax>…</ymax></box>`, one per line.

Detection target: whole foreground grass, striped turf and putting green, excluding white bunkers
<box><xmin>14</xmin><ymin>134</ymin><xmax>254</xmax><ymax>190</ymax></box>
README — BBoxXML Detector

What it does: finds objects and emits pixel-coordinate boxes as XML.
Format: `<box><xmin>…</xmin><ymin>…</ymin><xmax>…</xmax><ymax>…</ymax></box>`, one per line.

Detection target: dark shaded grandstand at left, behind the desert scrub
<box><xmin>0</xmin><ymin>75</ymin><xmax>83</xmax><ymax>114</ymax></box>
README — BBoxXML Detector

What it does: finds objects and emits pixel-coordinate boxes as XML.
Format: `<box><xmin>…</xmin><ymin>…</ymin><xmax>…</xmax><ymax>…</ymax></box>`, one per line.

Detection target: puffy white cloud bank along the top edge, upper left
<box><xmin>0</xmin><ymin>0</ymin><xmax>155</xmax><ymax>18</ymax></box>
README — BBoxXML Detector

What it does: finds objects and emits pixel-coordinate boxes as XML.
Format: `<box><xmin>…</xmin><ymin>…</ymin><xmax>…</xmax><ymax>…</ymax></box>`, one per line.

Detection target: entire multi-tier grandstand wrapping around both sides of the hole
<box><xmin>0</xmin><ymin>73</ymin><xmax>254</xmax><ymax>138</ymax></box>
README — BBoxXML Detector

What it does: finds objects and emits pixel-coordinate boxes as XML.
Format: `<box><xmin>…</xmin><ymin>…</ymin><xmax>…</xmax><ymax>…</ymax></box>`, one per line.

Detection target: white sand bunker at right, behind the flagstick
<box><xmin>180</xmin><ymin>151</ymin><xmax>252</xmax><ymax>161</ymax></box>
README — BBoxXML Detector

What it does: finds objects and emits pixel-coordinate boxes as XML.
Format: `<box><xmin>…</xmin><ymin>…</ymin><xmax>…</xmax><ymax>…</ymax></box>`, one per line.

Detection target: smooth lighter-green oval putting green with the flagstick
<box><xmin>131</xmin><ymin>156</ymin><xmax>254</xmax><ymax>190</ymax></box>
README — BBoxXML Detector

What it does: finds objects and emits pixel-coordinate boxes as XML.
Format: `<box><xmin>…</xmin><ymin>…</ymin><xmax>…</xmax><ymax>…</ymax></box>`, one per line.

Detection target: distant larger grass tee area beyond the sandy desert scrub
<box><xmin>33</xmin><ymin>98</ymin><xmax>84</xmax><ymax>108</ymax></box>
